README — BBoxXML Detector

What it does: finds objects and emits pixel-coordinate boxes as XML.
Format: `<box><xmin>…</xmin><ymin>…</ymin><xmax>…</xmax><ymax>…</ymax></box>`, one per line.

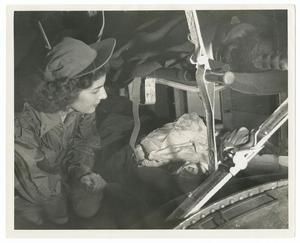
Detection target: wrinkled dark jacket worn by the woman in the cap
<box><xmin>15</xmin><ymin>104</ymin><xmax>100</xmax><ymax>223</ymax></box>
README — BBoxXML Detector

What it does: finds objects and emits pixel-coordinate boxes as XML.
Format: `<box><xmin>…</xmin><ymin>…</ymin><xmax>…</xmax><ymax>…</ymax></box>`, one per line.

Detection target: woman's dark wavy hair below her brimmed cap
<box><xmin>27</xmin><ymin>67</ymin><xmax>106</xmax><ymax>113</ymax></box>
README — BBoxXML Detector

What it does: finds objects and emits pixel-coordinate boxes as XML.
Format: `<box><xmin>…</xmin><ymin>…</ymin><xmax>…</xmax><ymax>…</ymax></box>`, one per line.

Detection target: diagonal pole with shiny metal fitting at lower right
<box><xmin>167</xmin><ymin>99</ymin><xmax>288</xmax><ymax>220</ymax></box>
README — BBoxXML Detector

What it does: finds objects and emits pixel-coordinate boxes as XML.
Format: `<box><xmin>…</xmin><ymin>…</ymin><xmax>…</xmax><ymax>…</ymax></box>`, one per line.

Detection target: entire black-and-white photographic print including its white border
<box><xmin>3</xmin><ymin>2</ymin><xmax>295</xmax><ymax>237</ymax></box>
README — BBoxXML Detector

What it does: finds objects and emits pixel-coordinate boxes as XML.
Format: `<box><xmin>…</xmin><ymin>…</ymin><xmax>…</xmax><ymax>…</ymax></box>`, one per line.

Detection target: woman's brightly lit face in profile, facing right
<box><xmin>71</xmin><ymin>75</ymin><xmax>107</xmax><ymax>113</ymax></box>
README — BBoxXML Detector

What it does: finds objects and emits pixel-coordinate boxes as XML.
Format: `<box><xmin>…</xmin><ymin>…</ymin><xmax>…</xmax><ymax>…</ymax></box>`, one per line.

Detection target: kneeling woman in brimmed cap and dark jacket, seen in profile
<box><xmin>15</xmin><ymin>37</ymin><xmax>115</xmax><ymax>227</ymax></box>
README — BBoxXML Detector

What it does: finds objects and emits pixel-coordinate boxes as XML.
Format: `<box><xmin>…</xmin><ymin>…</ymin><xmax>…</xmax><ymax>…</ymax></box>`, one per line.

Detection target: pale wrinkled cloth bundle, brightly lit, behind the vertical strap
<box><xmin>136</xmin><ymin>113</ymin><xmax>208</xmax><ymax>173</ymax></box>
